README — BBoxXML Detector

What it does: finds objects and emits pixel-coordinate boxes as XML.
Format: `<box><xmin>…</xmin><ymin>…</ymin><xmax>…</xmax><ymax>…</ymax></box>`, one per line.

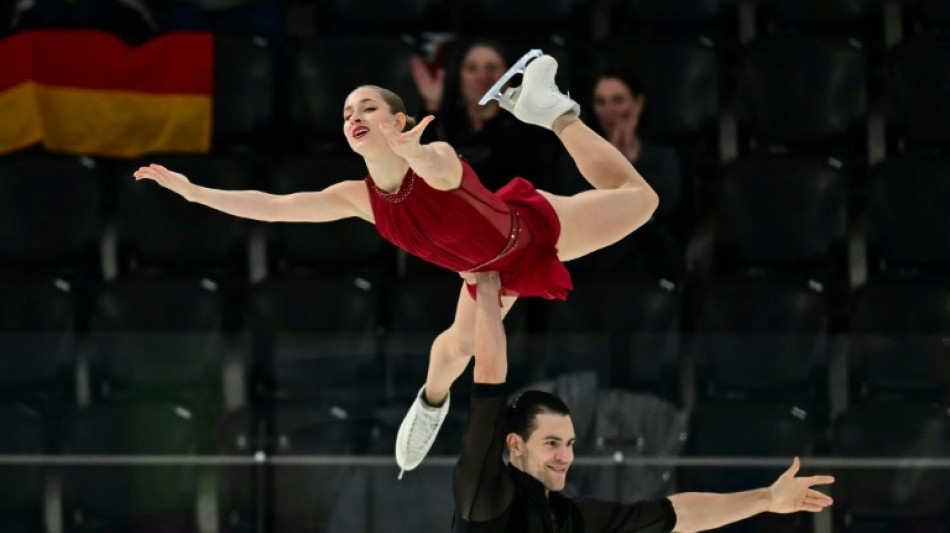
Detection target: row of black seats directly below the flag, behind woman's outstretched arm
<box><xmin>0</xmin><ymin>152</ymin><xmax>950</xmax><ymax>279</ymax></box>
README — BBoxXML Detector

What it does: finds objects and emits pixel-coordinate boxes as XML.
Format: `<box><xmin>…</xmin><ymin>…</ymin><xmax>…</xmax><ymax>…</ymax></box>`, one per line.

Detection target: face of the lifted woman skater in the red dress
<box><xmin>343</xmin><ymin>87</ymin><xmax>405</xmax><ymax>155</ymax></box>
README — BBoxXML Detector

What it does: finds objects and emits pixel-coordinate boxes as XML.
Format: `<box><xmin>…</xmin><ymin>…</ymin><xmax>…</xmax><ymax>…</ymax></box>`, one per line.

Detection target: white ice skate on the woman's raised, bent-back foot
<box><xmin>479</xmin><ymin>50</ymin><xmax>581</xmax><ymax>129</ymax></box>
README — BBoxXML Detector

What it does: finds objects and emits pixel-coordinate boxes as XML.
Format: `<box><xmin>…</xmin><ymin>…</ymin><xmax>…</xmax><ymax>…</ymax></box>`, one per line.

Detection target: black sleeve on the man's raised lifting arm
<box><xmin>453</xmin><ymin>383</ymin><xmax>514</xmax><ymax>522</ymax></box>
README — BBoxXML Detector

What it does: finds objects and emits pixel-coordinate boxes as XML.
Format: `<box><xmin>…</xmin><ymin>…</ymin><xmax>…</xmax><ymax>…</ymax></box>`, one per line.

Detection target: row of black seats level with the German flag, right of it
<box><xmin>214</xmin><ymin>34</ymin><xmax>950</xmax><ymax>159</ymax></box>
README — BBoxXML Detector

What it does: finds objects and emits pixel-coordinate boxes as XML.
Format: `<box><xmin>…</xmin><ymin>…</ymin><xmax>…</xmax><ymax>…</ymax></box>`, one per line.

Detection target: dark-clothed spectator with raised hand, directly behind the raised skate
<box><xmin>411</xmin><ymin>39</ymin><xmax>560</xmax><ymax>191</ymax></box>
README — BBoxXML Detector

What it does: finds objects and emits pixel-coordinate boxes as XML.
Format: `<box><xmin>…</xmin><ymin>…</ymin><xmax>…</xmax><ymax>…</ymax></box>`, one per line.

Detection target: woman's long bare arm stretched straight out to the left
<box><xmin>134</xmin><ymin>164</ymin><xmax>373</xmax><ymax>222</ymax></box>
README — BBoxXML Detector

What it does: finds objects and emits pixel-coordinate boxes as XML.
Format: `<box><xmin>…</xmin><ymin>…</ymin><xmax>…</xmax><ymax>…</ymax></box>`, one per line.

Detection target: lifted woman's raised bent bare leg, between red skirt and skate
<box><xmin>539</xmin><ymin>119</ymin><xmax>659</xmax><ymax>261</ymax></box>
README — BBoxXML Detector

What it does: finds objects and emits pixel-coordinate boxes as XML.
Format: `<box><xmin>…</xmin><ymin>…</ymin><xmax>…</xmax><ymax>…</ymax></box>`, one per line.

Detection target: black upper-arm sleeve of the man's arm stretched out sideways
<box><xmin>574</xmin><ymin>498</ymin><xmax>676</xmax><ymax>533</ymax></box>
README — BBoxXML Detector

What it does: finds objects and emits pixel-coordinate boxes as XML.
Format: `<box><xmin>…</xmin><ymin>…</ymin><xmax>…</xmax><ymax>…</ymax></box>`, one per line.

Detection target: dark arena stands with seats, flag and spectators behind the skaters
<box><xmin>0</xmin><ymin>0</ymin><xmax>950</xmax><ymax>533</ymax></box>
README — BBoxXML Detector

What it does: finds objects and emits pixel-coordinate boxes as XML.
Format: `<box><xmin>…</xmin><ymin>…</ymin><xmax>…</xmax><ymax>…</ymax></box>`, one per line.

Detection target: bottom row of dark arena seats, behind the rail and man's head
<box><xmin>0</xmin><ymin>387</ymin><xmax>950</xmax><ymax>531</ymax></box>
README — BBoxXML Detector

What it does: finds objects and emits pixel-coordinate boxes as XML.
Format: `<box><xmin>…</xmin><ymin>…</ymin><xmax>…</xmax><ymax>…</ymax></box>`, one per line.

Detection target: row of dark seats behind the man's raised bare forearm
<box><xmin>0</xmin><ymin>279</ymin><xmax>950</xmax><ymax>412</ymax></box>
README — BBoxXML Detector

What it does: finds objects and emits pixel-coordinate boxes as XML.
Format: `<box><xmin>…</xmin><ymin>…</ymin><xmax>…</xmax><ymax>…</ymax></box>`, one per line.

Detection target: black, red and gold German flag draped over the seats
<box><xmin>0</xmin><ymin>30</ymin><xmax>214</xmax><ymax>158</ymax></box>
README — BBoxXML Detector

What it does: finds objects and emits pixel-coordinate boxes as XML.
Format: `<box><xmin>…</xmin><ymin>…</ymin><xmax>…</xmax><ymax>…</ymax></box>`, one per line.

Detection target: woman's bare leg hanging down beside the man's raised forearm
<box><xmin>425</xmin><ymin>284</ymin><xmax>517</xmax><ymax>406</ymax></box>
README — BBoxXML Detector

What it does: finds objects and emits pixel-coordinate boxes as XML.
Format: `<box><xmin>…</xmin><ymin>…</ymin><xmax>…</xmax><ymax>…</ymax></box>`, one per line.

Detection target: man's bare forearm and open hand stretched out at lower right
<box><xmin>670</xmin><ymin>457</ymin><xmax>834</xmax><ymax>533</ymax></box>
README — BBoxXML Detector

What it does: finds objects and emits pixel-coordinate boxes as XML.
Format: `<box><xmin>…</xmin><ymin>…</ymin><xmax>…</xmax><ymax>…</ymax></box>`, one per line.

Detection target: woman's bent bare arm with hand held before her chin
<box><xmin>381</xmin><ymin>115</ymin><xmax>462</xmax><ymax>190</ymax></box>
